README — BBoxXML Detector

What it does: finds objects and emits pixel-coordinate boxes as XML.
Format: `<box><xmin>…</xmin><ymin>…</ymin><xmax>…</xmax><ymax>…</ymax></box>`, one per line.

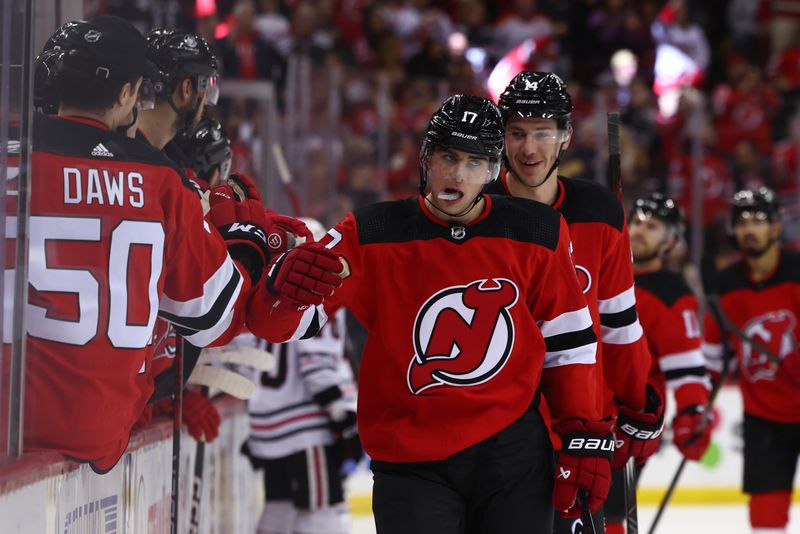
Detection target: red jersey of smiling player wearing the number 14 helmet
<box><xmin>487</xmin><ymin>173</ymin><xmax>651</xmax><ymax>417</ymax></box>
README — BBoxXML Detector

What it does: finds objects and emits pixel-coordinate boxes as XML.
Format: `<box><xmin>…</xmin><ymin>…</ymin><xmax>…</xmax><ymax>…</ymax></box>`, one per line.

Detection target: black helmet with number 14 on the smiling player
<box><xmin>498</xmin><ymin>70</ymin><xmax>573</xmax><ymax>130</ymax></box>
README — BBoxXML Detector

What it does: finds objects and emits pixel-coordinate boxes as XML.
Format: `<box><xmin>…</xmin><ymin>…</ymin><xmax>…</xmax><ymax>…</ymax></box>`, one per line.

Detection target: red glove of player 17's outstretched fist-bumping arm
<box><xmin>267</xmin><ymin>243</ymin><xmax>344</xmax><ymax>311</ymax></box>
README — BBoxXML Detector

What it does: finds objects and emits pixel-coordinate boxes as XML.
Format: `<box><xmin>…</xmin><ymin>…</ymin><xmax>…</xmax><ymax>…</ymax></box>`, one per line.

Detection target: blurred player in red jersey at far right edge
<box><xmin>703</xmin><ymin>187</ymin><xmax>800</xmax><ymax>534</ymax></box>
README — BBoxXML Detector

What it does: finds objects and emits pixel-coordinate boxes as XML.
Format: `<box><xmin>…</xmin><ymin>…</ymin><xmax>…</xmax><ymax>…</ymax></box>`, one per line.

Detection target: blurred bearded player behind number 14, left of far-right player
<box><xmin>604</xmin><ymin>193</ymin><xmax>711</xmax><ymax>534</ymax></box>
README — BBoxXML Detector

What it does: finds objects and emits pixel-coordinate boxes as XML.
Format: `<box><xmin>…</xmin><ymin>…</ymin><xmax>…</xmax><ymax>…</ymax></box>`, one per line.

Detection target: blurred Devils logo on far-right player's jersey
<box><xmin>741</xmin><ymin>310</ymin><xmax>797</xmax><ymax>382</ymax></box>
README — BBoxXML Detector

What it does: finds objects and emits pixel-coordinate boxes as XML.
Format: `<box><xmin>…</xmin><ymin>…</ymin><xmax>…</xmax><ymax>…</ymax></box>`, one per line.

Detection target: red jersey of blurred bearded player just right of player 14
<box><xmin>634</xmin><ymin>269</ymin><xmax>711</xmax><ymax>410</ymax></box>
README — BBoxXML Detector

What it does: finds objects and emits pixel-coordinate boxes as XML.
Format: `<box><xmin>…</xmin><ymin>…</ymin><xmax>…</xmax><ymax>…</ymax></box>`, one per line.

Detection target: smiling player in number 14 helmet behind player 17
<box><xmin>486</xmin><ymin>71</ymin><xmax>663</xmax><ymax>532</ymax></box>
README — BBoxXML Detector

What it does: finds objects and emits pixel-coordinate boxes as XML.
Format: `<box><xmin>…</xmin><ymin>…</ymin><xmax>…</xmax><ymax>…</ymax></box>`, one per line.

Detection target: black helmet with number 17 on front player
<box><xmin>419</xmin><ymin>94</ymin><xmax>504</xmax><ymax>194</ymax></box>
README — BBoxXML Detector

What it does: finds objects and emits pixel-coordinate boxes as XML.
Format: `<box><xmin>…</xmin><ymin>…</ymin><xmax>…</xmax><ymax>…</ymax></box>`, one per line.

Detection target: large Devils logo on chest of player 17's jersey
<box><xmin>408</xmin><ymin>278</ymin><xmax>519</xmax><ymax>395</ymax></box>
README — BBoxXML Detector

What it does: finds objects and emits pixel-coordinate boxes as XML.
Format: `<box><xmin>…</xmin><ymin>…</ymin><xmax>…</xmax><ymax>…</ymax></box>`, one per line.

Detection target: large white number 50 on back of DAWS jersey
<box><xmin>27</xmin><ymin>216</ymin><xmax>164</xmax><ymax>349</ymax></box>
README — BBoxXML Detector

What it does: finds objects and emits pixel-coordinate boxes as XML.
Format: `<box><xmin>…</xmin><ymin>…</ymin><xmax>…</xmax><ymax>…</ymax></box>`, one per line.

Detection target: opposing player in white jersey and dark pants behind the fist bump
<box><xmin>234</xmin><ymin>219</ymin><xmax>361</xmax><ymax>534</ymax></box>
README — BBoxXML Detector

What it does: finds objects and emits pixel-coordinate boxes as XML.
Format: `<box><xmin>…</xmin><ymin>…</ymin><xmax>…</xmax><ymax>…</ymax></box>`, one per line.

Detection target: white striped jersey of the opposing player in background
<box><xmin>234</xmin><ymin>309</ymin><xmax>356</xmax><ymax>458</ymax></box>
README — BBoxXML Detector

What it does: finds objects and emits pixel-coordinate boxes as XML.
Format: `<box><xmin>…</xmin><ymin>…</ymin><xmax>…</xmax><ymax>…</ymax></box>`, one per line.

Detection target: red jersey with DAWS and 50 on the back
<box><xmin>24</xmin><ymin>115</ymin><xmax>249</xmax><ymax>472</ymax></box>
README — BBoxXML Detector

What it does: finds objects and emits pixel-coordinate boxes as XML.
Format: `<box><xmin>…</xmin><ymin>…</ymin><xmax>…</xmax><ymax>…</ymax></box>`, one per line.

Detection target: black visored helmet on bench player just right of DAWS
<box><xmin>145</xmin><ymin>28</ymin><xmax>219</xmax><ymax>105</ymax></box>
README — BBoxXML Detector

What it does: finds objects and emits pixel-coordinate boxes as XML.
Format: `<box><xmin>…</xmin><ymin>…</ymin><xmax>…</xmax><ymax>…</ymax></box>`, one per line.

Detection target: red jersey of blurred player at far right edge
<box><xmin>703</xmin><ymin>250</ymin><xmax>800</xmax><ymax>423</ymax></box>
